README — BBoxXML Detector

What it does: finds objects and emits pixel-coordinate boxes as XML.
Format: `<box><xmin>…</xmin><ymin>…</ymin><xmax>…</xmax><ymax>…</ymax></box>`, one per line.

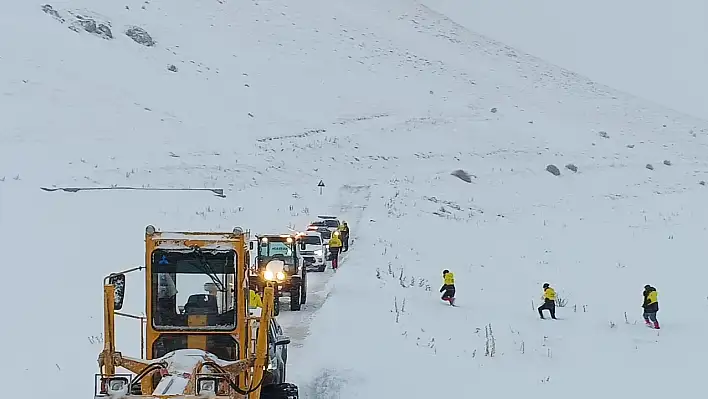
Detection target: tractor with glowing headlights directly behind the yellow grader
<box><xmin>249</xmin><ymin>234</ymin><xmax>307</xmax><ymax>316</ymax></box>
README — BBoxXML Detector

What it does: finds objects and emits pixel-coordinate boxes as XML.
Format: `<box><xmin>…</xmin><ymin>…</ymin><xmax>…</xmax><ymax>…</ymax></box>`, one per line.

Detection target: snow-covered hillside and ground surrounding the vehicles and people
<box><xmin>0</xmin><ymin>0</ymin><xmax>708</xmax><ymax>398</ymax></box>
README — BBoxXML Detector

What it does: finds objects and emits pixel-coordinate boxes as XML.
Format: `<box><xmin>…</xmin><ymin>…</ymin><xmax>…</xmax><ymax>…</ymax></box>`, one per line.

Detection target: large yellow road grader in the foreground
<box><xmin>94</xmin><ymin>226</ymin><xmax>299</xmax><ymax>399</ymax></box>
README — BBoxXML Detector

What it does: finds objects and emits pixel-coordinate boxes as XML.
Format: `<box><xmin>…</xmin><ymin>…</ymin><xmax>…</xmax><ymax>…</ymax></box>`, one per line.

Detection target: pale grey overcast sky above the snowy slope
<box><xmin>420</xmin><ymin>0</ymin><xmax>708</xmax><ymax>118</ymax></box>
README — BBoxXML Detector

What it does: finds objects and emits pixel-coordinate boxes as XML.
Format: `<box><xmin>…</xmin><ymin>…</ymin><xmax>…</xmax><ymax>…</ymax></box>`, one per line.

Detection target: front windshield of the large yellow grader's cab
<box><xmin>151</xmin><ymin>248</ymin><xmax>237</xmax><ymax>331</ymax></box>
